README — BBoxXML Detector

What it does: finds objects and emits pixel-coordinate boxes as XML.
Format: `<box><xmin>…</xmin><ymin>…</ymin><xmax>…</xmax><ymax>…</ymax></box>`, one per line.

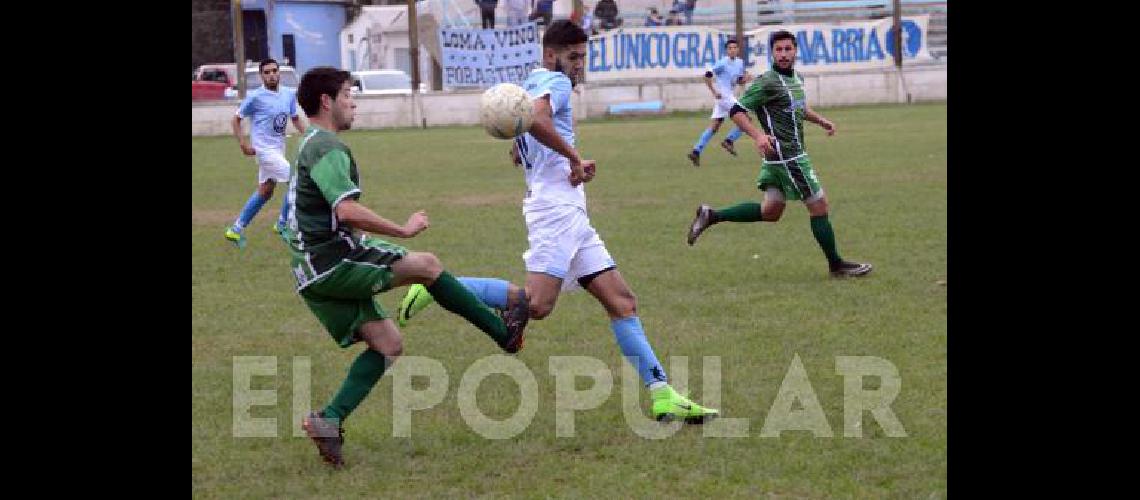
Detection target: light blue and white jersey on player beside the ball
<box><xmin>515</xmin><ymin>67</ymin><xmax>586</xmax><ymax>213</ymax></box>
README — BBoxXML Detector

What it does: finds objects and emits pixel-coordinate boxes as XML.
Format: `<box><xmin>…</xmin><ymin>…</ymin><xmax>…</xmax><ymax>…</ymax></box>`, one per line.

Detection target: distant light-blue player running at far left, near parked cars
<box><xmin>225</xmin><ymin>59</ymin><xmax>304</xmax><ymax>248</ymax></box>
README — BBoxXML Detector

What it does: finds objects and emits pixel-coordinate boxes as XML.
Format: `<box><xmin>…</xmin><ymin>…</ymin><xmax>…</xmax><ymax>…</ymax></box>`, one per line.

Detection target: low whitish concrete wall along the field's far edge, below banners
<box><xmin>192</xmin><ymin>64</ymin><xmax>947</xmax><ymax>136</ymax></box>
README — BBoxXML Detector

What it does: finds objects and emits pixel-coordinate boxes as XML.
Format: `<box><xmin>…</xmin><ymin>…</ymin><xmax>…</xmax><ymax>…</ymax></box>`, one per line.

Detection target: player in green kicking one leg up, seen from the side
<box><xmin>289</xmin><ymin>67</ymin><xmax>529</xmax><ymax>466</ymax></box>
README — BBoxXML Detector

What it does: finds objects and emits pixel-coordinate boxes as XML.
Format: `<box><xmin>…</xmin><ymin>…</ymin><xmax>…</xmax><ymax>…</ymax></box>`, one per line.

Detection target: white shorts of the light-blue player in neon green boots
<box><xmin>522</xmin><ymin>207</ymin><xmax>614</xmax><ymax>292</ymax></box>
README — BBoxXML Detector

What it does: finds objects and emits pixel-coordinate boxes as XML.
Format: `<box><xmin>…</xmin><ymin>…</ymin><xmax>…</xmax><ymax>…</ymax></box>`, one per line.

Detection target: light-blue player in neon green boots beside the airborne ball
<box><xmin>400</xmin><ymin>19</ymin><xmax>719</xmax><ymax>424</ymax></box>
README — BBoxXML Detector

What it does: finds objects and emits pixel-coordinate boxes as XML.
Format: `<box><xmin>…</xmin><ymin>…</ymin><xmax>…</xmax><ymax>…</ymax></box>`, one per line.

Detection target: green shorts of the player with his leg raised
<box><xmin>301</xmin><ymin>236</ymin><xmax>408</xmax><ymax>347</ymax></box>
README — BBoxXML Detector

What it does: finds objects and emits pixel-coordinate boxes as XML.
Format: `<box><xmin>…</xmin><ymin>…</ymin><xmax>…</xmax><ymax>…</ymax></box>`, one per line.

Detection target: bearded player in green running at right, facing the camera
<box><xmin>689</xmin><ymin>31</ymin><xmax>871</xmax><ymax>277</ymax></box>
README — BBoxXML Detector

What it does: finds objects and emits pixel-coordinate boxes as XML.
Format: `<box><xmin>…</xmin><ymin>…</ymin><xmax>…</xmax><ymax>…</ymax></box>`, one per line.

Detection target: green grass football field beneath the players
<box><xmin>192</xmin><ymin>104</ymin><xmax>946</xmax><ymax>499</ymax></box>
